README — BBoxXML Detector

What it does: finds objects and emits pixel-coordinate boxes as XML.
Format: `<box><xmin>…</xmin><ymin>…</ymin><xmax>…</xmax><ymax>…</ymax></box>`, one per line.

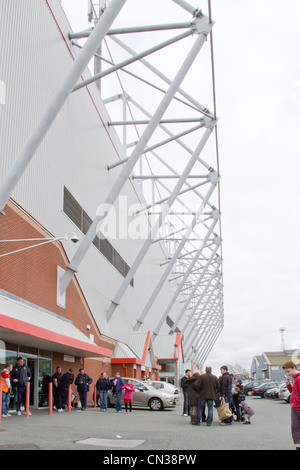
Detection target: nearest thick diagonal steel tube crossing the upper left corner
<box><xmin>0</xmin><ymin>0</ymin><xmax>126</xmax><ymax>214</ymax></box>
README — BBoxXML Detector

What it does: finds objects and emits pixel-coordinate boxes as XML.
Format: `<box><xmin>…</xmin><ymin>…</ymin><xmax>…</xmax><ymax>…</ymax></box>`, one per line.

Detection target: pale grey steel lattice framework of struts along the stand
<box><xmin>0</xmin><ymin>0</ymin><xmax>224</xmax><ymax>366</ymax></box>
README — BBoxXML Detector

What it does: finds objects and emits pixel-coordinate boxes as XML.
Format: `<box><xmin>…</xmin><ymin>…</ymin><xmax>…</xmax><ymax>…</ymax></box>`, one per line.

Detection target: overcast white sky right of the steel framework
<box><xmin>62</xmin><ymin>0</ymin><xmax>300</xmax><ymax>375</ymax></box>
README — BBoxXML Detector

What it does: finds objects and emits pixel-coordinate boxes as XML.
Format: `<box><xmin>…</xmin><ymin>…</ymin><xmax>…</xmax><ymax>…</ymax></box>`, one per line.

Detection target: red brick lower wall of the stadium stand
<box><xmin>0</xmin><ymin>201</ymin><xmax>115</xmax><ymax>402</ymax></box>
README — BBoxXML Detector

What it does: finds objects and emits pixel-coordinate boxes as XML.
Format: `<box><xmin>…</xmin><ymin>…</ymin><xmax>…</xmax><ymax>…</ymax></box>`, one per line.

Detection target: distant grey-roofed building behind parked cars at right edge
<box><xmin>251</xmin><ymin>349</ymin><xmax>300</xmax><ymax>381</ymax></box>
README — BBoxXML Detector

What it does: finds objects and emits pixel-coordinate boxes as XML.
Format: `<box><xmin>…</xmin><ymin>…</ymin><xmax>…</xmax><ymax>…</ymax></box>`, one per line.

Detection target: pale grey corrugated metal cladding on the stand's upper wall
<box><xmin>0</xmin><ymin>0</ymin><xmax>185</xmax><ymax>346</ymax></box>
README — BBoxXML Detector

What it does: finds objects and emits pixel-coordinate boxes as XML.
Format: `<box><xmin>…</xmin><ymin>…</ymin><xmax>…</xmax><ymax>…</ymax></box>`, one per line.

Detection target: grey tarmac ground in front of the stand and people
<box><xmin>0</xmin><ymin>397</ymin><xmax>294</xmax><ymax>454</ymax></box>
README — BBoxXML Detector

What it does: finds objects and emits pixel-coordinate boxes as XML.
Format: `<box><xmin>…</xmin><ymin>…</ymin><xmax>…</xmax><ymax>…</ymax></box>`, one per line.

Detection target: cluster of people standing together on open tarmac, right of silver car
<box><xmin>181</xmin><ymin>366</ymin><xmax>255</xmax><ymax>426</ymax></box>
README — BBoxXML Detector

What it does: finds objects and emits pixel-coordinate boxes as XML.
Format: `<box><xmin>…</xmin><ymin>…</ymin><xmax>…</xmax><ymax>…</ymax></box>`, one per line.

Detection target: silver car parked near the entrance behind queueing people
<box><xmin>107</xmin><ymin>377</ymin><xmax>178</xmax><ymax>411</ymax></box>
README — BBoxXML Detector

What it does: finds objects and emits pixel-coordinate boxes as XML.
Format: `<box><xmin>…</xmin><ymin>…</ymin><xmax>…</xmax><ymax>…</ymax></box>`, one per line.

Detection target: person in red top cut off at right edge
<box><xmin>282</xmin><ymin>361</ymin><xmax>300</xmax><ymax>450</ymax></box>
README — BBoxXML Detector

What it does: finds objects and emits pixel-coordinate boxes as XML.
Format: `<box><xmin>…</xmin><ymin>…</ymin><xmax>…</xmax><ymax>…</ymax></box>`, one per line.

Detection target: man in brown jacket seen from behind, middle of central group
<box><xmin>195</xmin><ymin>366</ymin><xmax>220</xmax><ymax>426</ymax></box>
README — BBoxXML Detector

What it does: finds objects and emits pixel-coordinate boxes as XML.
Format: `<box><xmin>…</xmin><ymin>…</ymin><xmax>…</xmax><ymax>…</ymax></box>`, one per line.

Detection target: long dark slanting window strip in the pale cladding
<box><xmin>63</xmin><ymin>186</ymin><xmax>134</xmax><ymax>287</ymax></box>
